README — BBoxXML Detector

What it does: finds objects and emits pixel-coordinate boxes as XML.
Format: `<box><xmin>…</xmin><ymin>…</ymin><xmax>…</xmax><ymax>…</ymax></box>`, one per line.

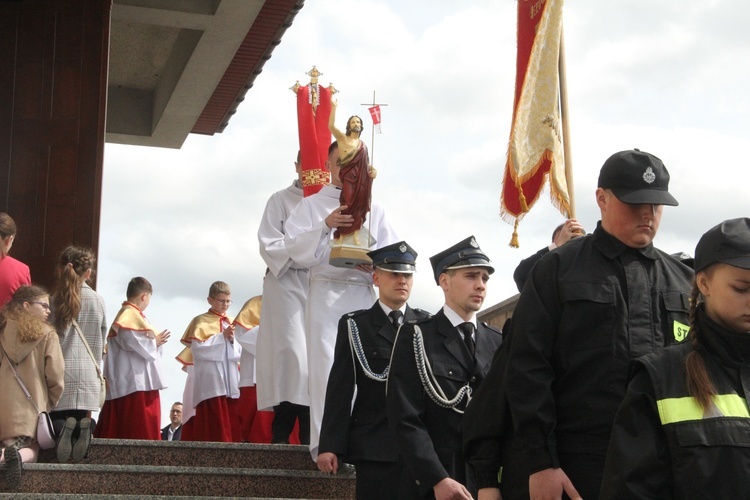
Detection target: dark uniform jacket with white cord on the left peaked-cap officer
<box><xmin>319</xmin><ymin>301</ymin><xmax>430</xmax><ymax>462</ymax></box>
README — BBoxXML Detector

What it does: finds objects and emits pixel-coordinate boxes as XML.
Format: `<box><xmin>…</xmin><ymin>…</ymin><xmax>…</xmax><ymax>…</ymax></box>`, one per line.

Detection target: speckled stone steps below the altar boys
<box><xmin>7</xmin><ymin>439</ymin><xmax>354</xmax><ymax>499</ymax></box>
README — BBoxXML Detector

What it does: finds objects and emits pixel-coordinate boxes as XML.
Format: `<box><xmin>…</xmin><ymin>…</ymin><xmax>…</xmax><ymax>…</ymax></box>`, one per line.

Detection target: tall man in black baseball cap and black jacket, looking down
<box><xmin>467</xmin><ymin>150</ymin><xmax>693</xmax><ymax>499</ymax></box>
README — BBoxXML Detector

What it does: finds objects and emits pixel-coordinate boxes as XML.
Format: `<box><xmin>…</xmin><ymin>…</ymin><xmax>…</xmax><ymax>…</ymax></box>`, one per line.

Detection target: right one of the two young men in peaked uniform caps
<box><xmin>386</xmin><ymin>236</ymin><xmax>502</xmax><ymax>498</ymax></box>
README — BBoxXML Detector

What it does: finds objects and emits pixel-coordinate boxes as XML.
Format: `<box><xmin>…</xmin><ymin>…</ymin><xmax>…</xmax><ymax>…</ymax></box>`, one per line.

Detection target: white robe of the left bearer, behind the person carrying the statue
<box><xmin>255</xmin><ymin>181</ymin><xmax>310</xmax><ymax>410</ymax></box>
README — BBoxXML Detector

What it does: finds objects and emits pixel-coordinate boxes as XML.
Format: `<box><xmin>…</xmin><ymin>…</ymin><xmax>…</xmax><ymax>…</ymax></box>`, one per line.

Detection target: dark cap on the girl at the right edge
<box><xmin>695</xmin><ymin>217</ymin><xmax>750</xmax><ymax>273</ymax></box>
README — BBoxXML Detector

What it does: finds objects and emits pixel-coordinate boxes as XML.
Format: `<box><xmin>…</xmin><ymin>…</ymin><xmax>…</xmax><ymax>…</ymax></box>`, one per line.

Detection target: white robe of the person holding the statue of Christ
<box><xmin>284</xmin><ymin>185</ymin><xmax>399</xmax><ymax>459</ymax></box>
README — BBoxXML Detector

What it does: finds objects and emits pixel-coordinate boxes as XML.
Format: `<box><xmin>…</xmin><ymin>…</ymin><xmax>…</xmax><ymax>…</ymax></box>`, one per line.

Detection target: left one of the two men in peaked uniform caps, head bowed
<box><xmin>318</xmin><ymin>241</ymin><xmax>430</xmax><ymax>500</ymax></box>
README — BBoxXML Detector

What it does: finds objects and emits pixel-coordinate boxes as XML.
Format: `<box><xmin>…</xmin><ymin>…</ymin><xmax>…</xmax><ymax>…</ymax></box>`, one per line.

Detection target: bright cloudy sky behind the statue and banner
<box><xmin>98</xmin><ymin>0</ymin><xmax>750</xmax><ymax>423</ymax></box>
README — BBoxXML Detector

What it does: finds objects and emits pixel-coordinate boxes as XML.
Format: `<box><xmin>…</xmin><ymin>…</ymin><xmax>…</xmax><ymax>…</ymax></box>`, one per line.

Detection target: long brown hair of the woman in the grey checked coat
<box><xmin>52</xmin><ymin>245</ymin><xmax>95</xmax><ymax>333</ymax></box>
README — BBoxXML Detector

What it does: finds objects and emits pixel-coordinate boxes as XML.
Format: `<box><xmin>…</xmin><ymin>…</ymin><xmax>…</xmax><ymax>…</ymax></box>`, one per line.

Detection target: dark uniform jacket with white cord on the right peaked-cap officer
<box><xmin>386</xmin><ymin>309</ymin><xmax>502</xmax><ymax>498</ymax></box>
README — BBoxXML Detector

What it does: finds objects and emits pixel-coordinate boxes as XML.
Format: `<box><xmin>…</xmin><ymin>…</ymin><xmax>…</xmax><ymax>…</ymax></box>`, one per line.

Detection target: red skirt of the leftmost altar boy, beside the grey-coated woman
<box><xmin>94</xmin><ymin>391</ymin><xmax>161</xmax><ymax>441</ymax></box>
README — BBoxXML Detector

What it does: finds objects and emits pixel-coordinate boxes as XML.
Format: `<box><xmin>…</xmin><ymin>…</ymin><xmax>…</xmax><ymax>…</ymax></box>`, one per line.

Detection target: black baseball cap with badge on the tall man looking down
<box><xmin>598</xmin><ymin>149</ymin><xmax>679</xmax><ymax>206</ymax></box>
